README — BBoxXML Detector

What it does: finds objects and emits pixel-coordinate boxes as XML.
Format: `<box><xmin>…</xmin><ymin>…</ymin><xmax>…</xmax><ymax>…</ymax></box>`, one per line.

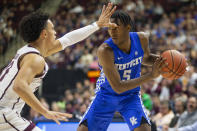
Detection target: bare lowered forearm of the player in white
<box><xmin>13</xmin><ymin>82</ymin><xmax>48</xmax><ymax>114</ymax></box>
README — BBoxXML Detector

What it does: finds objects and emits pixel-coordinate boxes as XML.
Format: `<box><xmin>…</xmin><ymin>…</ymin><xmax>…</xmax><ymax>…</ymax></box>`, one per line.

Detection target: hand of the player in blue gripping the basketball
<box><xmin>151</xmin><ymin>57</ymin><xmax>168</xmax><ymax>78</ymax></box>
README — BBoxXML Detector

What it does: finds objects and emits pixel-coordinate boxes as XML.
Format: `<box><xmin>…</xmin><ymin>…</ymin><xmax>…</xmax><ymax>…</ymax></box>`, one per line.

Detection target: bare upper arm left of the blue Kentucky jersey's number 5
<box><xmin>98</xmin><ymin>44</ymin><xmax>121</xmax><ymax>89</ymax></box>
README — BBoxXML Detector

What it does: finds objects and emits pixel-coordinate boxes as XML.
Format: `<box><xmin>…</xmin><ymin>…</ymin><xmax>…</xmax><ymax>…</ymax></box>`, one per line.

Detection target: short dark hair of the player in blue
<box><xmin>111</xmin><ymin>10</ymin><xmax>135</xmax><ymax>31</ymax></box>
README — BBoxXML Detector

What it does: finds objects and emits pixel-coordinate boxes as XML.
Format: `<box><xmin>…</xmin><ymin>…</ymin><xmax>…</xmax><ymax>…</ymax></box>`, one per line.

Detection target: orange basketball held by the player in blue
<box><xmin>161</xmin><ymin>50</ymin><xmax>187</xmax><ymax>80</ymax></box>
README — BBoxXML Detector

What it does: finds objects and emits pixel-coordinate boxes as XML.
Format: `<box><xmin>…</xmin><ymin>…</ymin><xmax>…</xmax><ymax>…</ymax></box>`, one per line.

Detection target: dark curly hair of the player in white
<box><xmin>19</xmin><ymin>10</ymin><xmax>49</xmax><ymax>43</ymax></box>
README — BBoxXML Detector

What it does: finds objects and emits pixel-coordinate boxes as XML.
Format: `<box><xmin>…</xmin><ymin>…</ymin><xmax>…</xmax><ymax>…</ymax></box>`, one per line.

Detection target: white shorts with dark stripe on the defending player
<box><xmin>0</xmin><ymin>108</ymin><xmax>41</xmax><ymax>131</ymax></box>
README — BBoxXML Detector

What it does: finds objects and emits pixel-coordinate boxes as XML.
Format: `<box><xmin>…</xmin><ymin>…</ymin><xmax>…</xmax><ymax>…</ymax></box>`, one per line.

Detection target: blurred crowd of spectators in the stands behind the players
<box><xmin>0</xmin><ymin>0</ymin><xmax>197</xmax><ymax>131</ymax></box>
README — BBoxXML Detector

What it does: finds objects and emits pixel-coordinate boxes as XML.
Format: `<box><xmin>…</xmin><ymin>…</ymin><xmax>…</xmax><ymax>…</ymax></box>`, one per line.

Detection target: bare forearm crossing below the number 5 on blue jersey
<box><xmin>117</xmin><ymin>73</ymin><xmax>153</xmax><ymax>93</ymax></box>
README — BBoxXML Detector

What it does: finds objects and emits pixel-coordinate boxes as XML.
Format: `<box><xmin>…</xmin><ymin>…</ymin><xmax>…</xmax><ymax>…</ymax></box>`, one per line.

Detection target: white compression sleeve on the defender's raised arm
<box><xmin>58</xmin><ymin>22</ymin><xmax>99</xmax><ymax>49</ymax></box>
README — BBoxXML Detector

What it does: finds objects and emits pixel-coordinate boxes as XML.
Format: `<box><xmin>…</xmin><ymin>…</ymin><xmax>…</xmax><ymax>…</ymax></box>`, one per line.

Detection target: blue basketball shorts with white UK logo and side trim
<box><xmin>79</xmin><ymin>92</ymin><xmax>151</xmax><ymax>131</ymax></box>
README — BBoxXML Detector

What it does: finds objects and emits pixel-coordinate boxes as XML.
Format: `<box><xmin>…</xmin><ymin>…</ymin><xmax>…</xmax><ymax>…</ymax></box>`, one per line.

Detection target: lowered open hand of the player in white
<box><xmin>43</xmin><ymin>111</ymin><xmax>72</xmax><ymax>125</ymax></box>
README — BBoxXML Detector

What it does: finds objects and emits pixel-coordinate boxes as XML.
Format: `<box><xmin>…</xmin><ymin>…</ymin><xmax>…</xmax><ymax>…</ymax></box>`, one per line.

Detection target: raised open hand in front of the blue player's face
<box><xmin>96</xmin><ymin>3</ymin><xmax>117</xmax><ymax>28</ymax></box>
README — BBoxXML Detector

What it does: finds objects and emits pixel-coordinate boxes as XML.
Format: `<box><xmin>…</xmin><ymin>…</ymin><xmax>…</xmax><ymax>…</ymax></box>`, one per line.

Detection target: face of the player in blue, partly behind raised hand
<box><xmin>108</xmin><ymin>18</ymin><xmax>129</xmax><ymax>44</ymax></box>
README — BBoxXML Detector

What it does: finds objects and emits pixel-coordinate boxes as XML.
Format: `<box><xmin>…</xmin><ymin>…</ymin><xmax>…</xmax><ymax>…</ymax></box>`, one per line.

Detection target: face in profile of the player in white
<box><xmin>46</xmin><ymin>20</ymin><xmax>56</xmax><ymax>43</ymax></box>
